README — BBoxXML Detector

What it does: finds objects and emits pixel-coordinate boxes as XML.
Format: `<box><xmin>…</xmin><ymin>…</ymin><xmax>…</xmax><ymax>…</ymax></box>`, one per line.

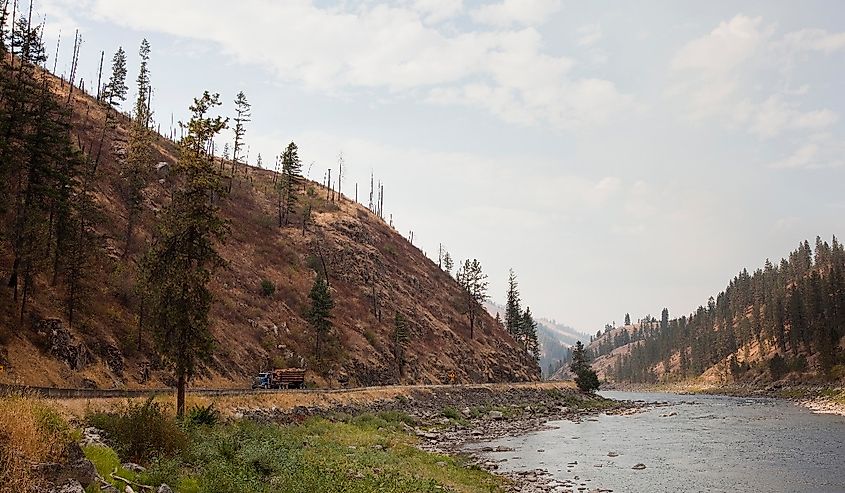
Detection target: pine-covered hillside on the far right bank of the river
<box><xmin>572</xmin><ymin>237</ymin><xmax>845</xmax><ymax>385</ymax></box>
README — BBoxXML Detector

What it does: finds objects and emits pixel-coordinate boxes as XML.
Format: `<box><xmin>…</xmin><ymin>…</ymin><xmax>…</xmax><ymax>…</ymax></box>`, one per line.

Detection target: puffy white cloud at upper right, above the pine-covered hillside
<box><xmin>668</xmin><ymin>14</ymin><xmax>845</xmax><ymax>160</ymax></box>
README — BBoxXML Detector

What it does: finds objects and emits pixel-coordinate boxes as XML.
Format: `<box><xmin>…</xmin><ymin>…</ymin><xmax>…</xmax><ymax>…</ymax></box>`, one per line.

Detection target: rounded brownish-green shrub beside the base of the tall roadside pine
<box><xmin>86</xmin><ymin>397</ymin><xmax>188</xmax><ymax>463</ymax></box>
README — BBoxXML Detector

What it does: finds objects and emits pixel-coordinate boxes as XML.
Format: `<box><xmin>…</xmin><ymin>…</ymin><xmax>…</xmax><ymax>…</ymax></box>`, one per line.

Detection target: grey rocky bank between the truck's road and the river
<box><xmin>241</xmin><ymin>386</ymin><xmax>645</xmax><ymax>493</ymax></box>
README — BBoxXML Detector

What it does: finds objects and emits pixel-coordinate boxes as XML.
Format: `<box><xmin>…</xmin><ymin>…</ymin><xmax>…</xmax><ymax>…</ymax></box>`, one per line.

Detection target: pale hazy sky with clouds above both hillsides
<box><xmin>35</xmin><ymin>0</ymin><xmax>845</xmax><ymax>332</ymax></box>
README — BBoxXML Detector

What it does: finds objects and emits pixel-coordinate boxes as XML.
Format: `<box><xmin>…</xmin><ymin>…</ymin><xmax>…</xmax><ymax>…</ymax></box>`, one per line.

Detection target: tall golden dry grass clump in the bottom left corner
<box><xmin>0</xmin><ymin>395</ymin><xmax>73</xmax><ymax>493</ymax></box>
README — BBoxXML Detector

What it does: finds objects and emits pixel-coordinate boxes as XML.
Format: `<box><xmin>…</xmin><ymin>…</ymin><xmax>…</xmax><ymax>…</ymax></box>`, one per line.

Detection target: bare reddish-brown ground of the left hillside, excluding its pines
<box><xmin>0</xmin><ymin>57</ymin><xmax>539</xmax><ymax>388</ymax></box>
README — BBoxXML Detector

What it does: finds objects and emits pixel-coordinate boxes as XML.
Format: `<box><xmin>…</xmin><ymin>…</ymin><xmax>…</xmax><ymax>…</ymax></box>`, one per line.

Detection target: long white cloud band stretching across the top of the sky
<box><xmin>50</xmin><ymin>0</ymin><xmax>635</xmax><ymax>128</ymax></box>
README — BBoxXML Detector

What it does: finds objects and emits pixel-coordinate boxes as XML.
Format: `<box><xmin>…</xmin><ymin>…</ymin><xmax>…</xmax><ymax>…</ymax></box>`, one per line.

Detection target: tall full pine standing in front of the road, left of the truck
<box><xmin>142</xmin><ymin>91</ymin><xmax>228</xmax><ymax>417</ymax></box>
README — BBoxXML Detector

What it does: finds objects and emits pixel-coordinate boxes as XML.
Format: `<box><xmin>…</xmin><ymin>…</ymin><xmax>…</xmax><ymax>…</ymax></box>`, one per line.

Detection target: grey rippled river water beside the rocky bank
<box><xmin>471</xmin><ymin>392</ymin><xmax>845</xmax><ymax>493</ymax></box>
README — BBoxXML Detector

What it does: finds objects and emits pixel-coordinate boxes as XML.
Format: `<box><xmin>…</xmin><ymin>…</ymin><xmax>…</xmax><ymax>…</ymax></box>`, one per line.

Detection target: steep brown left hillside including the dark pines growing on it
<box><xmin>0</xmin><ymin>21</ymin><xmax>539</xmax><ymax>388</ymax></box>
